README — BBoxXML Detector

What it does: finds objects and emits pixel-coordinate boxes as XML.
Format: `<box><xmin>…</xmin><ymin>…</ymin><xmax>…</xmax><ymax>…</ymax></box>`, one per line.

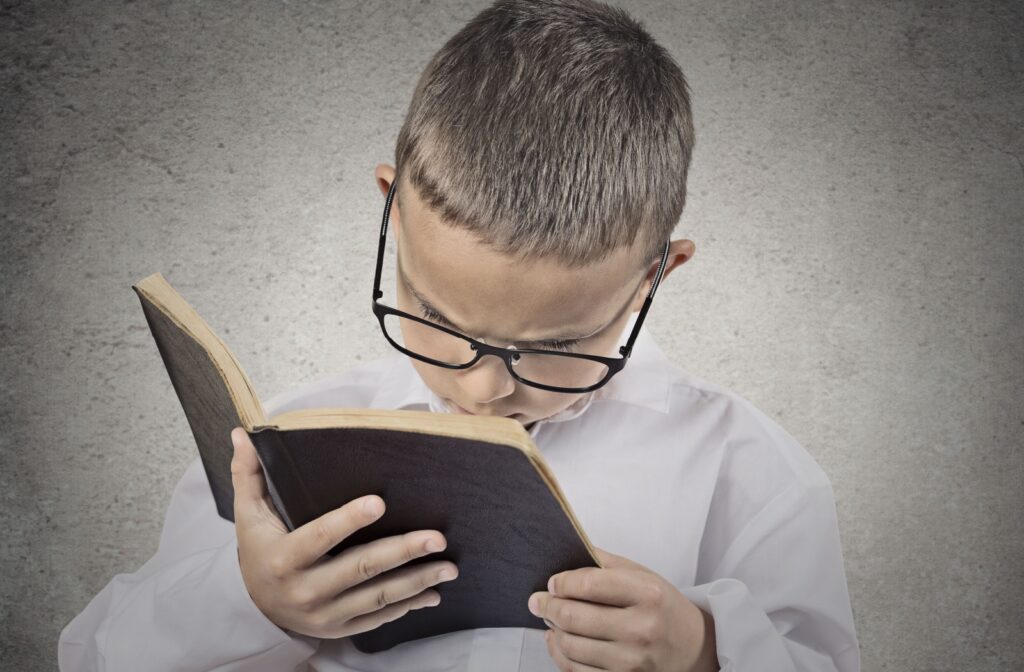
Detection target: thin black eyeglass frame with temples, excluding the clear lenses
<box><xmin>373</xmin><ymin>178</ymin><xmax>670</xmax><ymax>394</ymax></box>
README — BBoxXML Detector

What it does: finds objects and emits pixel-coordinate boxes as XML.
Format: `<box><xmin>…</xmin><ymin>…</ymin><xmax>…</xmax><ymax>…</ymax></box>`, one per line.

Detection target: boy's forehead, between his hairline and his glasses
<box><xmin>398</xmin><ymin>186</ymin><xmax>643</xmax><ymax>341</ymax></box>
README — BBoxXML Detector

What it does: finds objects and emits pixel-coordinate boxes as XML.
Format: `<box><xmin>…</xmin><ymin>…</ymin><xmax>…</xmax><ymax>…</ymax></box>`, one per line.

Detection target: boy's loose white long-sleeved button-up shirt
<box><xmin>58</xmin><ymin>313</ymin><xmax>860</xmax><ymax>672</ymax></box>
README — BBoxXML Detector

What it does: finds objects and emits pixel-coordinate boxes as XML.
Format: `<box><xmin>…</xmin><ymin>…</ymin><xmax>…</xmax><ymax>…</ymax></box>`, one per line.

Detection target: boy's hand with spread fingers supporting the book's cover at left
<box><xmin>231</xmin><ymin>427</ymin><xmax>458</xmax><ymax>639</ymax></box>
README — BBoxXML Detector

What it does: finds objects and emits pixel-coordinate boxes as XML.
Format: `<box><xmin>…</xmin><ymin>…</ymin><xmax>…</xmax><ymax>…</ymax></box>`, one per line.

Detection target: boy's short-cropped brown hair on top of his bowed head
<box><xmin>395</xmin><ymin>0</ymin><xmax>694</xmax><ymax>267</ymax></box>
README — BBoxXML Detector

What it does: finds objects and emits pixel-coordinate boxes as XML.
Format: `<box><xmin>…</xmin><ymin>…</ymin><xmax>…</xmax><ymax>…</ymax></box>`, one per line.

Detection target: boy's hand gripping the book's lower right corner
<box><xmin>529</xmin><ymin>548</ymin><xmax>719</xmax><ymax>672</ymax></box>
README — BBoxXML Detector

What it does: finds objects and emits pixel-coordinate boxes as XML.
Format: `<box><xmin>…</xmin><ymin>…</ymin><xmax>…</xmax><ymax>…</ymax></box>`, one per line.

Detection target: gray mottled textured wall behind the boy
<box><xmin>0</xmin><ymin>0</ymin><xmax>1024</xmax><ymax>670</ymax></box>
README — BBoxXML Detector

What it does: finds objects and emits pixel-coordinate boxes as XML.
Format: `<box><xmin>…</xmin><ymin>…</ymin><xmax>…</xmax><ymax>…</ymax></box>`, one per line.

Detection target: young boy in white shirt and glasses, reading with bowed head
<box><xmin>59</xmin><ymin>0</ymin><xmax>859</xmax><ymax>672</ymax></box>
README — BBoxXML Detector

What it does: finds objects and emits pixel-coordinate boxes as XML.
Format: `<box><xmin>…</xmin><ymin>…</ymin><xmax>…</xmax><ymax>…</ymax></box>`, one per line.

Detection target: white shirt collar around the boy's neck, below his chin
<box><xmin>370</xmin><ymin>312</ymin><xmax>673</xmax><ymax>434</ymax></box>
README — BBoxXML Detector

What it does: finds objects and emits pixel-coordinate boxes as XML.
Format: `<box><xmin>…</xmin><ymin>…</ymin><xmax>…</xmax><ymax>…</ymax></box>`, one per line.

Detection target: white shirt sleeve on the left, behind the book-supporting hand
<box><xmin>57</xmin><ymin>457</ymin><xmax>319</xmax><ymax>672</ymax></box>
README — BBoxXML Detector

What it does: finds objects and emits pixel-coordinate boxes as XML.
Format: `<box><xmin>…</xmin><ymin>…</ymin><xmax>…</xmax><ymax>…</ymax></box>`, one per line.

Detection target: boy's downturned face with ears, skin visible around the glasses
<box><xmin>376</xmin><ymin>165</ymin><xmax>693</xmax><ymax>429</ymax></box>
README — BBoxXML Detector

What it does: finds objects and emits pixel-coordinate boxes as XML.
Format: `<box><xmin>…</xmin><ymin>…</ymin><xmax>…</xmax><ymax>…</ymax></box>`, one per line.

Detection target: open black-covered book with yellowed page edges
<box><xmin>132</xmin><ymin>272</ymin><xmax>601</xmax><ymax>654</ymax></box>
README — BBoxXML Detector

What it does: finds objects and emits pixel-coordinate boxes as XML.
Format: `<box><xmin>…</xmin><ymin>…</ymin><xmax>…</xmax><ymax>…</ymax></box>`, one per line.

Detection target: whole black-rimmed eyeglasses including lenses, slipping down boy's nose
<box><xmin>373</xmin><ymin>179</ymin><xmax>669</xmax><ymax>393</ymax></box>
